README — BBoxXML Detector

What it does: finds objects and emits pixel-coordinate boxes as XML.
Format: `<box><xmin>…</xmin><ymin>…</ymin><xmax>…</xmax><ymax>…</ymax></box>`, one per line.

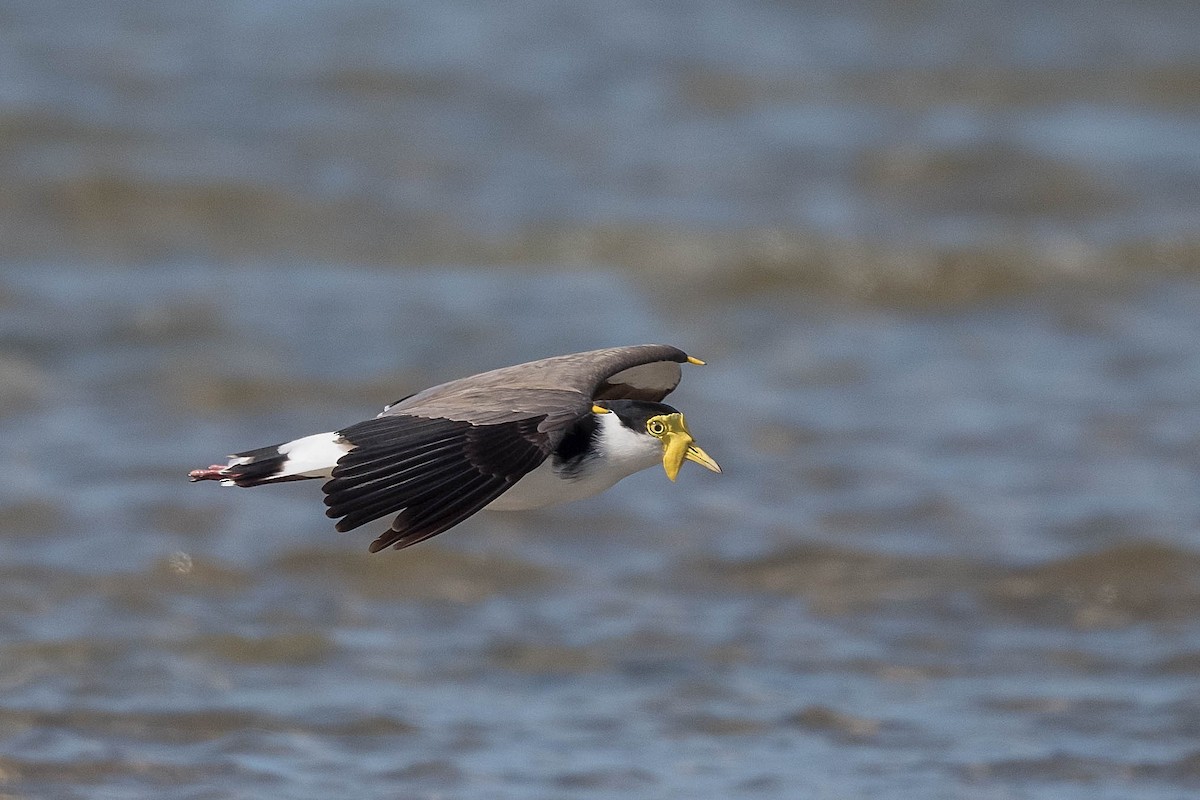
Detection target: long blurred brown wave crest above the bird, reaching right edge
<box><xmin>537</xmin><ymin>224</ymin><xmax>1200</xmax><ymax>308</ymax></box>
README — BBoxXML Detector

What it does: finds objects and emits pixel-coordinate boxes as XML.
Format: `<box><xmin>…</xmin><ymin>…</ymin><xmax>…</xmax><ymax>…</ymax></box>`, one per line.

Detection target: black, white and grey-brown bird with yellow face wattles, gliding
<box><xmin>187</xmin><ymin>344</ymin><xmax>721</xmax><ymax>553</ymax></box>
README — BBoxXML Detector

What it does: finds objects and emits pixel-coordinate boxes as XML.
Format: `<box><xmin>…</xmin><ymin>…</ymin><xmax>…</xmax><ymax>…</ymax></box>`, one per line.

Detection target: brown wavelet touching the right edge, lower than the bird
<box><xmin>984</xmin><ymin>542</ymin><xmax>1200</xmax><ymax>628</ymax></box>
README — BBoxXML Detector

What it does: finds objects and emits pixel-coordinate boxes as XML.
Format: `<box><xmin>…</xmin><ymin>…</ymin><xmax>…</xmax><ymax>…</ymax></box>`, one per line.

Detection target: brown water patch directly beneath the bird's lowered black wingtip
<box><xmin>275</xmin><ymin>543</ymin><xmax>554</xmax><ymax>603</ymax></box>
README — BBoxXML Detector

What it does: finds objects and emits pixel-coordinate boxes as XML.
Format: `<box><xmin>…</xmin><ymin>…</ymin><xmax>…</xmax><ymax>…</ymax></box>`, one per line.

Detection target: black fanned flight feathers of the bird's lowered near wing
<box><xmin>322</xmin><ymin>415</ymin><xmax>550</xmax><ymax>553</ymax></box>
